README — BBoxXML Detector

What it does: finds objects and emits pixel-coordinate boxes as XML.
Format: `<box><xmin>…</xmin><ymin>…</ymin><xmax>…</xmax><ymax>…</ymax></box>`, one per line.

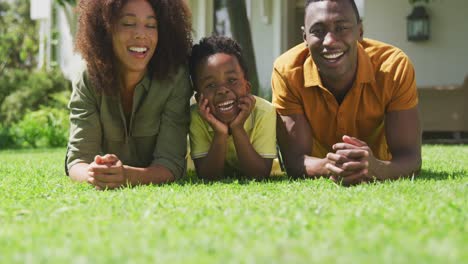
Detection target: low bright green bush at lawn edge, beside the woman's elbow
<box><xmin>12</xmin><ymin>107</ymin><xmax>69</xmax><ymax>148</ymax></box>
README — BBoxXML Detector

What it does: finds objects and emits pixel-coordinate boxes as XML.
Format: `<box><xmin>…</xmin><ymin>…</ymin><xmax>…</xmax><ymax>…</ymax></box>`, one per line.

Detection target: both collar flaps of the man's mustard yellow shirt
<box><xmin>304</xmin><ymin>43</ymin><xmax>375</xmax><ymax>88</ymax></box>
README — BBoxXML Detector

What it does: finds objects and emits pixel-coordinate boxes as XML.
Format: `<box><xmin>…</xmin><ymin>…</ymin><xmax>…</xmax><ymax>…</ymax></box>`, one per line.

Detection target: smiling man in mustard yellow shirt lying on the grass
<box><xmin>272</xmin><ymin>0</ymin><xmax>421</xmax><ymax>185</ymax></box>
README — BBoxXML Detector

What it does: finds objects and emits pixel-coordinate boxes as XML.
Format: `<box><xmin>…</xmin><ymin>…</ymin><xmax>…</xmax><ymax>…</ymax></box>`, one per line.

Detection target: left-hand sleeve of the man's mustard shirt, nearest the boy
<box><xmin>271</xmin><ymin>67</ymin><xmax>304</xmax><ymax>115</ymax></box>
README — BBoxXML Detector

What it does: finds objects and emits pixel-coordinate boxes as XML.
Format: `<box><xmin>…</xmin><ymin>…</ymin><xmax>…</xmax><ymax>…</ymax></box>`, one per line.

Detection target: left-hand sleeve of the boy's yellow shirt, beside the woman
<box><xmin>190</xmin><ymin>104</ymin><xmax>212</xmax><ymax>159</ymax></box>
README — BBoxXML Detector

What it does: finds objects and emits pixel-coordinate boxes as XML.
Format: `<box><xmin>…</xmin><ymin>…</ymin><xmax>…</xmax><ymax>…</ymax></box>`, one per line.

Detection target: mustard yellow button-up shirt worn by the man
<box><xmin>271</xmin><ymin>39</ymin><xmax>418</xmax><ymax>160</ymax></box>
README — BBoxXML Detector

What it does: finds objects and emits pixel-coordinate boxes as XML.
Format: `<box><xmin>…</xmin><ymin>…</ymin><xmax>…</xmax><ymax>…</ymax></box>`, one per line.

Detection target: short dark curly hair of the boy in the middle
<box><xmin>189</xmin><ymin>36</ymin><xmax>249</xmax><ymax>90</ymax></box>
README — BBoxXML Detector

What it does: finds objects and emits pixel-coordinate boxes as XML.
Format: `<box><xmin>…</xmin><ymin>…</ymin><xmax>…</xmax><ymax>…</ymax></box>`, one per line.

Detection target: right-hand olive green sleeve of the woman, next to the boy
<box><xmin>152</xmin><ymin>68</ymin><xmax>192</xmax><ymax>179</ymax></box>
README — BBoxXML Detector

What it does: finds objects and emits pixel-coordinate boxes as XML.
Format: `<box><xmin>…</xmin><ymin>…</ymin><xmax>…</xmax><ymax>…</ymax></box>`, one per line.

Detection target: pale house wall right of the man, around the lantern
<box><xmin>364</xmin><ymin>0</ymin><xmax>468</xmax><ymax>88</ymax></box>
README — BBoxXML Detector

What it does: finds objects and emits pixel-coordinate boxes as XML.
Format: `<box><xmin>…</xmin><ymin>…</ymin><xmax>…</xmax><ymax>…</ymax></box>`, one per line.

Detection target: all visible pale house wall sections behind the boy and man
<box><xmin>189</xmin><ymin>0</ymin><xmax>468</xmax><ymax>90</ymax></box>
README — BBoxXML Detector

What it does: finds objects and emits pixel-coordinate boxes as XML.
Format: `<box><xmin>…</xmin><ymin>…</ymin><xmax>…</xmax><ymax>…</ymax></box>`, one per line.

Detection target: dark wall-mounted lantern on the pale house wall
<box><xmin>406</xmin><ymin>5</ymin><xmax>430</xmax><ymax>41</ymax></box>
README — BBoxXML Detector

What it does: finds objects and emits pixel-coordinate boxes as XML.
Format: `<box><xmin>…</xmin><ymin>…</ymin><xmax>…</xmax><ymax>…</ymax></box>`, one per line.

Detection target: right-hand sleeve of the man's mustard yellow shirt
<box><xmin>387</xmin><ymin>52</ymin><xmax>418</xmax><ymax>112</ymax></box>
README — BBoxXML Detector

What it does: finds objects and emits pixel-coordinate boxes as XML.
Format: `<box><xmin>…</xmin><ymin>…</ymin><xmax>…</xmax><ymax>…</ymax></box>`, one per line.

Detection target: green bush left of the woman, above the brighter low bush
<box><xmin>0</xmin><ymin>69</ymin><xmax>71</xmax><ymax>126</ymax></box>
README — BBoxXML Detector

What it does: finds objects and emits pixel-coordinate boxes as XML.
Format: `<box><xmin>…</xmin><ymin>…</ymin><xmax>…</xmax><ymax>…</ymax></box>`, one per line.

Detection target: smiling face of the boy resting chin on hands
<box><xmin>196</xmin><ymin>53</ymin><xmax>251</xmax><ymax>124</ymax></box>
